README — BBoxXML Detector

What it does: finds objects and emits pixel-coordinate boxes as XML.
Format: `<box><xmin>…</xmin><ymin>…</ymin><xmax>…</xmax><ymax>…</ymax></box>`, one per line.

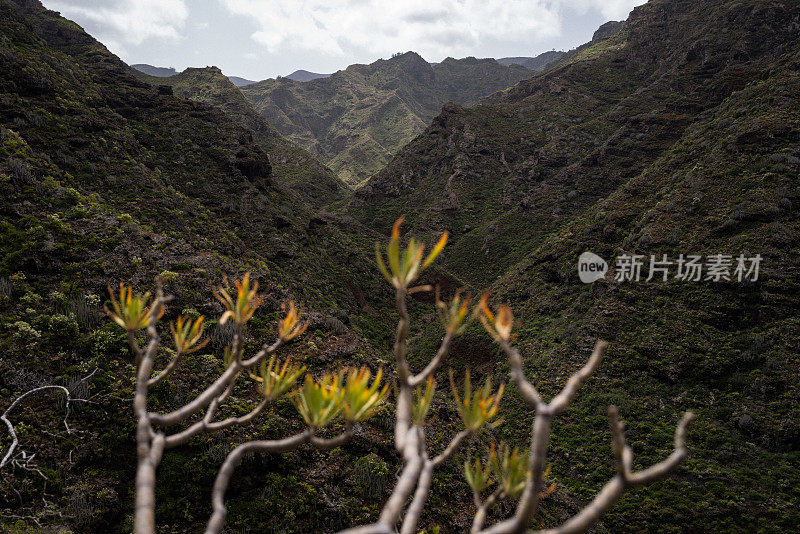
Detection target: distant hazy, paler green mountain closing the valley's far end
<box><xmin>242</xmin><ymin>52</ymin><xmax>532</xmax><ymax>185</ymax></box>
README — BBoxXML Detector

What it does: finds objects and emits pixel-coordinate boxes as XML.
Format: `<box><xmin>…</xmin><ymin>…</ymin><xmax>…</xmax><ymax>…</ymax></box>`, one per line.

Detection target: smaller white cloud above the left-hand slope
<box><xmin>44</xmin><ymin>0</ymin><xmax>189</xmax><ymax>56</ymax></box>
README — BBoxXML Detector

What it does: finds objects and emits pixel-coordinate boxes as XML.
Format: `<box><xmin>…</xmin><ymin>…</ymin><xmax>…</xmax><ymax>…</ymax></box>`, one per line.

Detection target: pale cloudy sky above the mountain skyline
<box><xmin>43</xmin><ymin>0</ymin><xmax>644</xmax><ymax>80</ymax></box>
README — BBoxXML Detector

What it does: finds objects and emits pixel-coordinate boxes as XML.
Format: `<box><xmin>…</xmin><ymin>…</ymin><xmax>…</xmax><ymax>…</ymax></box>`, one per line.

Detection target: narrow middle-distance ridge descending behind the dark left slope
<box><xmin>132</xmin><ymin>63</ymin><xmax>346</xmax><ymax>207</ymax></box>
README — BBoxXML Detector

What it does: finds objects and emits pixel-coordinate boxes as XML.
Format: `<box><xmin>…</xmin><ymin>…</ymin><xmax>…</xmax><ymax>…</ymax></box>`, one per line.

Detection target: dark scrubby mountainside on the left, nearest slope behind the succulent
<box><xmin>0</xmin><ymin>0</ymin><xmax>400</xmax><ymax>533</ymax></box>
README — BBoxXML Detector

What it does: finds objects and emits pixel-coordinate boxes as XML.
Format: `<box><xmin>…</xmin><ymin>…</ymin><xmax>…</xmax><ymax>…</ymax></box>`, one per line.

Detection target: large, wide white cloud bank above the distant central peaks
<box><xmin>218</xmin><ymin>0</ymin><xmax>644</xmax><ymax>59</ymax></box>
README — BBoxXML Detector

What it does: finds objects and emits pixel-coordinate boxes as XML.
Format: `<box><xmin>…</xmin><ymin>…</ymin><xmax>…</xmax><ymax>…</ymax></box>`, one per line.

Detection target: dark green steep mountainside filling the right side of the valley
<box><xmin>348</xmin><ymin>0</ymin><xmax>800</xmax><ymax>532</ymax></box>
